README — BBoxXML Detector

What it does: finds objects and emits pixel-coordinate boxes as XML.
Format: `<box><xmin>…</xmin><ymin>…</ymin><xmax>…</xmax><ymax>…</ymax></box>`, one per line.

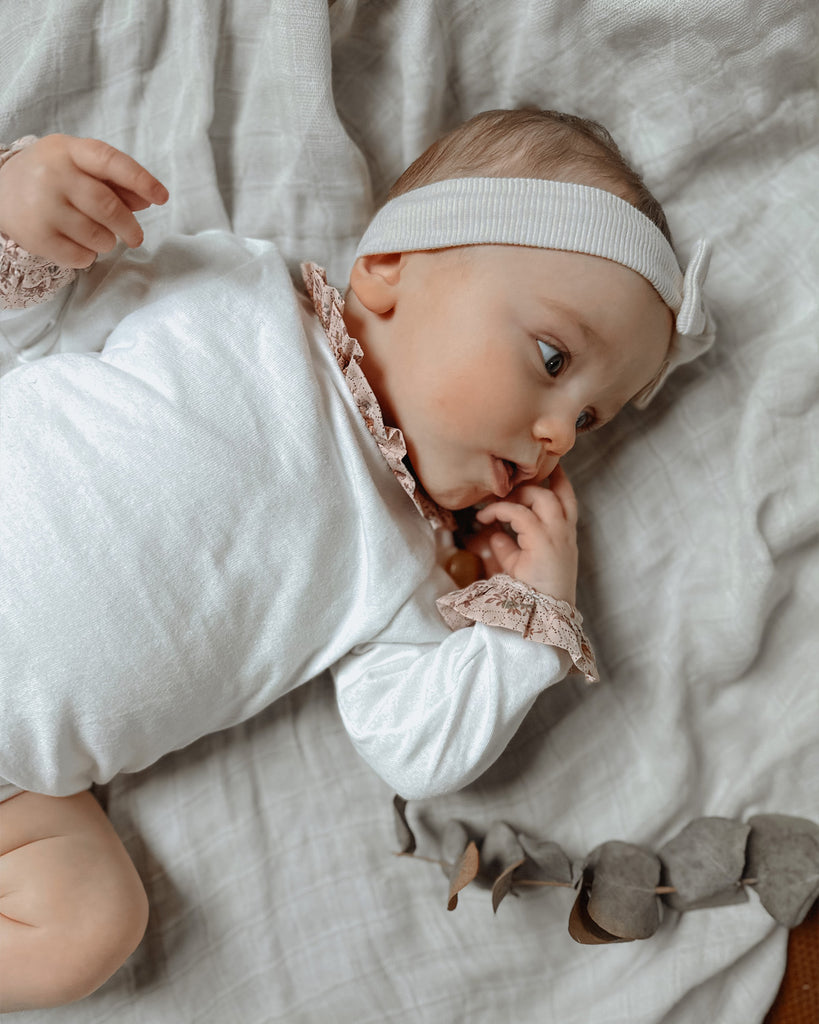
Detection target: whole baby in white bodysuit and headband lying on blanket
<box><xmin>0</xmin><ymin>111</ymin><xmax>712</xmax><ymax>1010</ymax></box>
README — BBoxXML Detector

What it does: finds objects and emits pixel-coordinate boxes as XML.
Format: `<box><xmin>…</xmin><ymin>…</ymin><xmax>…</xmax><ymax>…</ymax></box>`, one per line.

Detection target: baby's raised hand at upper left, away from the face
<box><xmin>0</xmin><ymin>135</ymin><xmax>168</xmax><ymax>268</ymax></box>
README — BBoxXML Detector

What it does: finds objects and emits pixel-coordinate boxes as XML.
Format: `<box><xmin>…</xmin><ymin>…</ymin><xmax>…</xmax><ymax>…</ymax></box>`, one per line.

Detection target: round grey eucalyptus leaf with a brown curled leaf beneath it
<box><xmin>585</xmin><ymin>840</ymin><xmax>661</xmax><ymax>939</ymax></box>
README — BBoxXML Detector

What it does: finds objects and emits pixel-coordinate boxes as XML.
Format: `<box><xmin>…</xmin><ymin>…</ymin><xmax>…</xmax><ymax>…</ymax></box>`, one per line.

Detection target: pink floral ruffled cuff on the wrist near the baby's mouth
<box><xmin>436</xmin><ymin>573</ymin><xmax>600</xmax><ymax>683</ymax></box>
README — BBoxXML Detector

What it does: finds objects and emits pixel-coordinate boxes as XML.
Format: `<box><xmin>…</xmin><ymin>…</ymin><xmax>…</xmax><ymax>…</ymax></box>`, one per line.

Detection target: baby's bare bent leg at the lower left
<box><xmin>0</xmin><ymin>793</ymin><xmax>147</xmax><ymax>1013</ymax></box>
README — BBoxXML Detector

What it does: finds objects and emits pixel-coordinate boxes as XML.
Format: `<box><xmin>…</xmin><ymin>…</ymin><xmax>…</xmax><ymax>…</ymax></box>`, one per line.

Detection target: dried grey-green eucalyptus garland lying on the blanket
<box><xmin>393</xmin><ymin>796</ymin><xmax>819</xmax><ymax>944</ymax></box>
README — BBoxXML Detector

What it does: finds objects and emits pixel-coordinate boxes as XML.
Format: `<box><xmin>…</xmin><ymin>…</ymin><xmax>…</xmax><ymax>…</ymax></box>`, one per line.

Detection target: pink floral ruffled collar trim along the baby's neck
<box><xmin>301</xmin><ymin>263</ymin><xmax>455</xmax><ymax>529</ymax></box>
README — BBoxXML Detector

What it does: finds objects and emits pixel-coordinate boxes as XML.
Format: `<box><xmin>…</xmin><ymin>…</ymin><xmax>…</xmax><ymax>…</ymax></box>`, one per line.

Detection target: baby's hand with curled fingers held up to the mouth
<box><xmin>476</xmin><ymin>466</ymin><xmax>577</xmax><ymax>604</ymax></box>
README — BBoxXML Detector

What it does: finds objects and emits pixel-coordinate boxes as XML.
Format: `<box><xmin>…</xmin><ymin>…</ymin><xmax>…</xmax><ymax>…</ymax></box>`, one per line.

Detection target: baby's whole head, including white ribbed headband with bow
<box><xmin>345</xmin><ymin>111</ymin><xmax>708</xmax><ymax>509</ymax></box>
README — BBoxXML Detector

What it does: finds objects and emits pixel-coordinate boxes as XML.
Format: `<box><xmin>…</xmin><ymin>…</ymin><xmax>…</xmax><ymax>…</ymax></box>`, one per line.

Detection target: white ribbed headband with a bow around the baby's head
<box><xmin>355</xmin><ymin>178</ymin><xmax>714</xmax><ymax>407</ymax></box>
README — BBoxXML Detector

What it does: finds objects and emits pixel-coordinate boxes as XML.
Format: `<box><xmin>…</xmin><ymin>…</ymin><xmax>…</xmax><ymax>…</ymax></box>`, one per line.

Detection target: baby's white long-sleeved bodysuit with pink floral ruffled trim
<box><xmin>0</xmin><ymin>222</ymin><xmax>594</xmax><ymax>798</ymax></box>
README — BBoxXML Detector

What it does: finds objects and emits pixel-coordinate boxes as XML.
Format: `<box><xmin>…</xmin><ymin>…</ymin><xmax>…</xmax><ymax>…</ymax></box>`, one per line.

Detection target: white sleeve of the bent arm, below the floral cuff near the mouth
<box><xmin>332</xmin><ymin>581</ymin><xmax>572</xmax><ymax>800</ymax></box>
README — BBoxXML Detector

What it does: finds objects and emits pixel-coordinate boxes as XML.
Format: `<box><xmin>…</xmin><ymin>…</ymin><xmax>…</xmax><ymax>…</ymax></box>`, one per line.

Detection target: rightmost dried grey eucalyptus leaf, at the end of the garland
<box><xmin>745</xmin><ymin>814</ymin><xmax>819</xmax><ymax>928</ymax></box>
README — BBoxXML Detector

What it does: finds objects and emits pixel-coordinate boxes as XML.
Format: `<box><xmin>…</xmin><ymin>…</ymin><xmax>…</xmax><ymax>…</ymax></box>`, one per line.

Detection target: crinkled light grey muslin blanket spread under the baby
<box><xmin>0</xmin><ymin>0</ymin><xmax>819</xmax><ymax>1024</ymax></box>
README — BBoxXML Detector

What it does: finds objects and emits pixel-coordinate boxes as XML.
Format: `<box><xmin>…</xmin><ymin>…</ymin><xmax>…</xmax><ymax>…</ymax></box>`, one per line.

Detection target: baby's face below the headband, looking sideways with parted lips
<box><xmin>358</xmin><ymin>246</ymin><xmax>673</xmax><ymax>509</ymax></box>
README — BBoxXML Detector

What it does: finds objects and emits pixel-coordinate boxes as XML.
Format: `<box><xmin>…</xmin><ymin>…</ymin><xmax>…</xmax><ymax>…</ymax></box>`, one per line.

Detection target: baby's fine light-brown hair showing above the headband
<box><xmin>387</xmin><ymin>108</ymin><xmax>672</xmax><ymax>242</ymax></box>
